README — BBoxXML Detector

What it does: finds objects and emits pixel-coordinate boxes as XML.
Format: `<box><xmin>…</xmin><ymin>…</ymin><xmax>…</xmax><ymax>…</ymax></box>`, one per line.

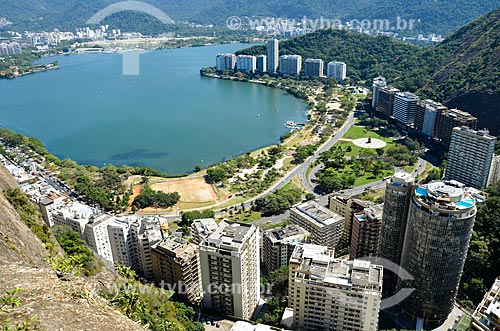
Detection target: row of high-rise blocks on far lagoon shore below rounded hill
<box><xmin>216</xmin><ymin>39</ymin><xmax>347</xmax><ymax>82</ymax></box>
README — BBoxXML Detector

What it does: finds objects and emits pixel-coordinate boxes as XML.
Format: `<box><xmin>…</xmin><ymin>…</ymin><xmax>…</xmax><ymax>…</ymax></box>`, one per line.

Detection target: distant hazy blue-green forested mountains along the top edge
<box><xmin>0</xmin><ymin>0</ymin><xmax>500</xmax><ymax>34</ymax></box>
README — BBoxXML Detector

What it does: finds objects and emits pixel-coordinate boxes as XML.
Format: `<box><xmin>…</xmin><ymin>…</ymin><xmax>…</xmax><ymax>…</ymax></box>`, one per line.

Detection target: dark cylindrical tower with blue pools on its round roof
<box><xmin>399</xmin><ymin>181</ymin><xmax>477</xmax><ymax>324</ymax></box>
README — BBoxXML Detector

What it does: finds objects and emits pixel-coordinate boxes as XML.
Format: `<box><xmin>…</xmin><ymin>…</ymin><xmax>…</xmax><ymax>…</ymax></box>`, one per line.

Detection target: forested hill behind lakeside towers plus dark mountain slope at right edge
<box><xmin>238</xmin><ymin>9</ymin><xmax>500</xmax><ymax>134</ymax></box>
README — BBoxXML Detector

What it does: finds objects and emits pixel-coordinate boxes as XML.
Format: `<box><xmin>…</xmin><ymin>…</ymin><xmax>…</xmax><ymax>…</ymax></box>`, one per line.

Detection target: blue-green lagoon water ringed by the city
<box><xmin>0</xmin><ymin>44</ymin><xmax>306</xmax><ymax>173</ymax></box>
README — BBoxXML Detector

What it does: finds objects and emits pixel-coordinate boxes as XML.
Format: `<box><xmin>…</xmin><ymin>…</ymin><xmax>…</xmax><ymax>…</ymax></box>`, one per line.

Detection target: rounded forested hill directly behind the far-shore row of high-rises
<box><xmin>238</xmin><ymin>30</ymin><xmax>426</xmax><ymax>90</ymax></box>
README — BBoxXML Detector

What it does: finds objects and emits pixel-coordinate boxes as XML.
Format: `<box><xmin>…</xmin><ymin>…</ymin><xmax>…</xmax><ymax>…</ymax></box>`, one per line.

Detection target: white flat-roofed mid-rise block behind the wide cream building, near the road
<box><xmin>290</xmin><ymin>201</ymin><xmax>345</xmax><ymax>249</ymax></box>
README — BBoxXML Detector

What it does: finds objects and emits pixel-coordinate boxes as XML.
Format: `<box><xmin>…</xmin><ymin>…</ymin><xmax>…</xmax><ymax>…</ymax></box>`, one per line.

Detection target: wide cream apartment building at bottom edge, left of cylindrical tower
<box><xmin>288</xmin><ymin>244</ymin><xmax>383</xmax><ymax>331</ymax></box>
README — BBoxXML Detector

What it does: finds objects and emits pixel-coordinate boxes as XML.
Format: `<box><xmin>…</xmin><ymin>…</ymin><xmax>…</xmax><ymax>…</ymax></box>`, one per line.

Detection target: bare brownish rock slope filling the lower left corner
<box><xmin>0</xmin><ymin>164</ymin><xmax>144</xmax><ymax>331</ymax></box>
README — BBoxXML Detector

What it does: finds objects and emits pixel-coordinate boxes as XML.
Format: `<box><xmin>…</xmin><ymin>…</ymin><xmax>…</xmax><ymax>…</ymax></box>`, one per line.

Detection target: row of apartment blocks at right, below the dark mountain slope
<box><xmin>372</xmin><ymin>77</ymin><xmax>500</xmax><ymax>189</ymax></box>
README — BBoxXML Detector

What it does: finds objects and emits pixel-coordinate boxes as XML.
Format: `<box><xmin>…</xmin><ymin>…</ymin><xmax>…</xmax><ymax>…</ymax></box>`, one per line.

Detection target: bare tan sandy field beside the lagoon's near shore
<box><xmin>151</xmin><ymin>177</ymin><xmax>217</xmax><ymax>203</ymax></box>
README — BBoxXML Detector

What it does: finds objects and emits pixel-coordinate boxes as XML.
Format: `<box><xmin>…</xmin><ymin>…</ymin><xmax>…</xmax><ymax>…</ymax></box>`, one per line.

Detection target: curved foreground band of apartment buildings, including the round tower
<box><xmin>0</xmin><ymin>127</ymin><xmax>492</xmax><ymax>331</ymax></box>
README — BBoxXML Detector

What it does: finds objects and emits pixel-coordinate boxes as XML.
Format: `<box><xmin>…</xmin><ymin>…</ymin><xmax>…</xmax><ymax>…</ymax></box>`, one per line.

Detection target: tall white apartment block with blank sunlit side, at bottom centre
<box><xmin>199</xmin><ymin>221</ymin><xmax>260</xmax><ymax>320</ymax></box>
